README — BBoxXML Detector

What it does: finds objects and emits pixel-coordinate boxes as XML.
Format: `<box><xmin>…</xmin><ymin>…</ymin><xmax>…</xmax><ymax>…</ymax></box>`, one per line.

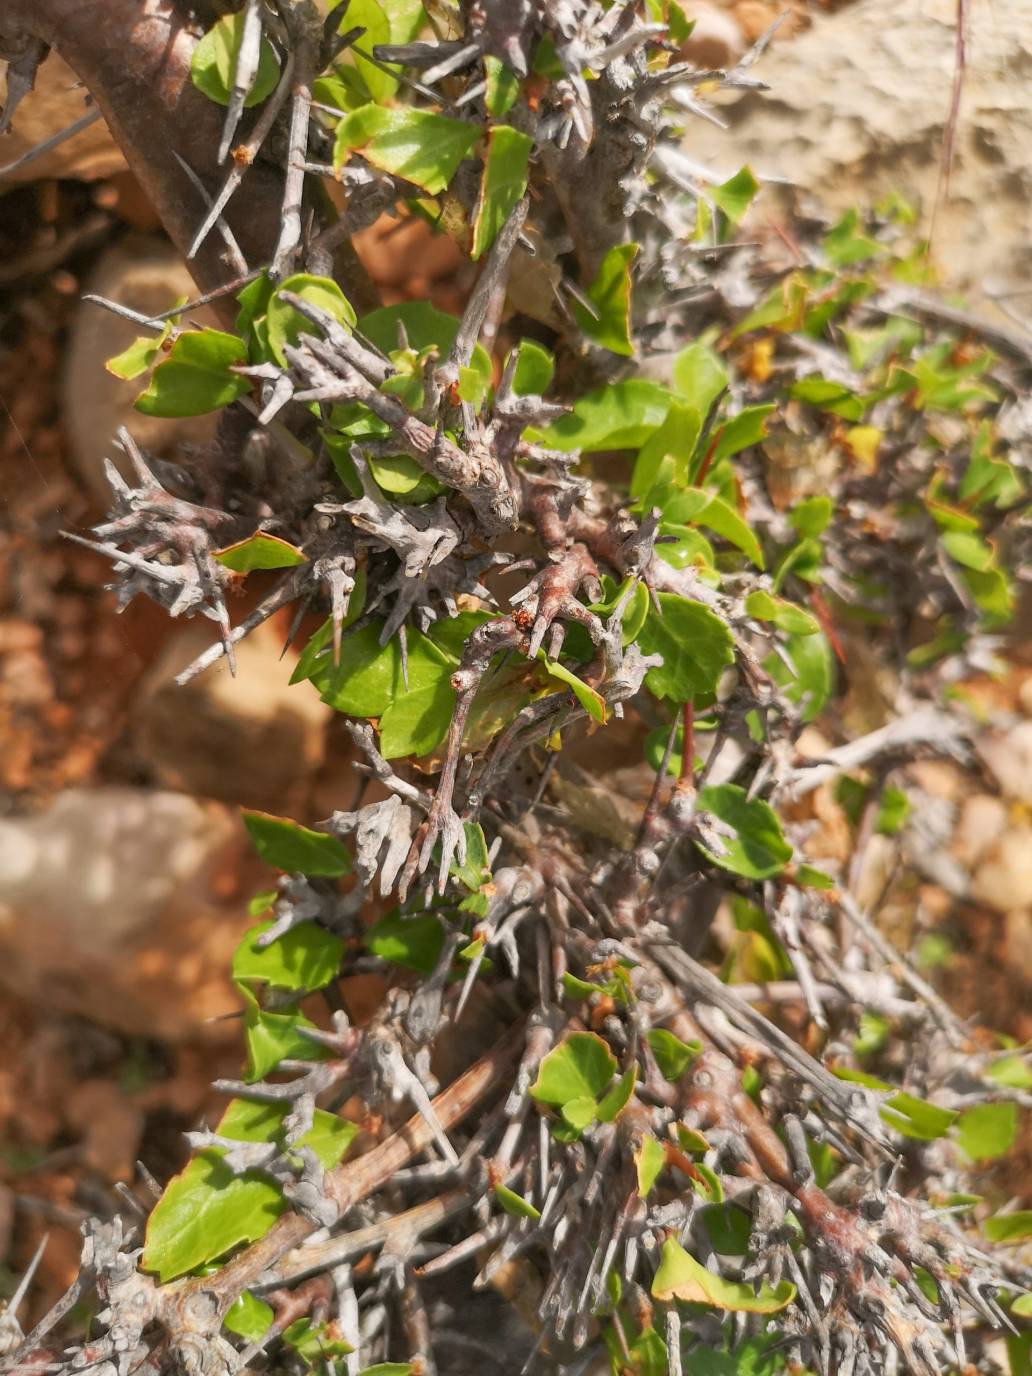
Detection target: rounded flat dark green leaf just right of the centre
<box><xmin>638</xmin><ymin>593</ymin><xmax>735</xmax><ymax>702</ymax></box>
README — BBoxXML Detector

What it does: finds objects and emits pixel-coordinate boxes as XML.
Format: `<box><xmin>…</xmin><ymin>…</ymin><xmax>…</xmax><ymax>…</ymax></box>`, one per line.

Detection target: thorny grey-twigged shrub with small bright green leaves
<box><xmin>7</xmin><ymin>0</ymin><xmax>1032</xmax><ymax>1376</ymax></box>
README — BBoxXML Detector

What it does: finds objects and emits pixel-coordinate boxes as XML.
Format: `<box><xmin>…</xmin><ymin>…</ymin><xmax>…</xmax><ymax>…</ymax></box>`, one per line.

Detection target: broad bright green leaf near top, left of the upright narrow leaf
<box><xmin>333</xmin><ymin>105</ymin><xmax>480</xmax><ymax>195</ymax></box>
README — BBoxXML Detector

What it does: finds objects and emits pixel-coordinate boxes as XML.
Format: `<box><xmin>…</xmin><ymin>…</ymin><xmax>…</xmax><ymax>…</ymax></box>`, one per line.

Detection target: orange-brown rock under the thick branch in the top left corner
<box><xmin>0</xmin><ymin>52</ymin><xmax>125</xmax><ymax>189</ymax></box>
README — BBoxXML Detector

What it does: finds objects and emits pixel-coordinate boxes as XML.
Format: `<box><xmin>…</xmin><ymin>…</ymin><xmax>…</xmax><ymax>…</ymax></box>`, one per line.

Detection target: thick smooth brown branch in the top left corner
<box><xmin>0</xmin><ymin>0</ymin><xmax>281</xmax><ymax>321</ymax></box>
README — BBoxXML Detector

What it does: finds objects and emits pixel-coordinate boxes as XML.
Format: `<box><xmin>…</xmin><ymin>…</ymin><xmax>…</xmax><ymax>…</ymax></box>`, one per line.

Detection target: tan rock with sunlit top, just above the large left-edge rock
<box><xmin>132</xmin><ymin>618</ymin><xmax>333</xmax><ymax>815</ymax></box>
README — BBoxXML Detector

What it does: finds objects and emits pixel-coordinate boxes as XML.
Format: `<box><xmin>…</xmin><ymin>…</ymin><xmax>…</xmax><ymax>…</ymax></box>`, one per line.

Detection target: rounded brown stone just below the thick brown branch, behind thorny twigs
<box><xmin>62</xmin><ymin>235</ymin><xmax>217</xmax><ymax>506</ymax></box>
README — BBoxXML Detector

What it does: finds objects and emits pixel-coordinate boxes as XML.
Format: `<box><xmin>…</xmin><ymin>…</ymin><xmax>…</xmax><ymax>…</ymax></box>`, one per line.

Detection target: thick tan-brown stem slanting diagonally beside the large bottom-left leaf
<box><xmin>183</xmin><ymin>1024</ymin><xmax>523</xmax><ymax>1314</ymax></box>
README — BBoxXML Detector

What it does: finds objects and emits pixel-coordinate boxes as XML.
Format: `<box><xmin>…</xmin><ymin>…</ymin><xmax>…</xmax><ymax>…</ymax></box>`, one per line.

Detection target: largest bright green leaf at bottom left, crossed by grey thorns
<box><xmin>143</xmin><ymin>1099</ymin><xmax>358</xmax><ymax>1284</ymax></box>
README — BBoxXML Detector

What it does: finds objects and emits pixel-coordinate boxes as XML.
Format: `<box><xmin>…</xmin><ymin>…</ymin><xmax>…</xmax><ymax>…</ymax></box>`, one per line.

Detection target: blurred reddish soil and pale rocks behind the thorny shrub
<box><xmin>0</xmin><ymin>0</ymin><xmax>1032</xmax><ymax>1331</ymax></box>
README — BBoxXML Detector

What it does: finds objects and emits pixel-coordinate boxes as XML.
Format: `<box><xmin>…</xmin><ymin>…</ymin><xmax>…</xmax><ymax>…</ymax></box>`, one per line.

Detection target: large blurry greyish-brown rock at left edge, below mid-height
<box><xmin>0</xmin><ymin>788</ymin><xmax>249</xmax><ymax>1040</ymax></box>
